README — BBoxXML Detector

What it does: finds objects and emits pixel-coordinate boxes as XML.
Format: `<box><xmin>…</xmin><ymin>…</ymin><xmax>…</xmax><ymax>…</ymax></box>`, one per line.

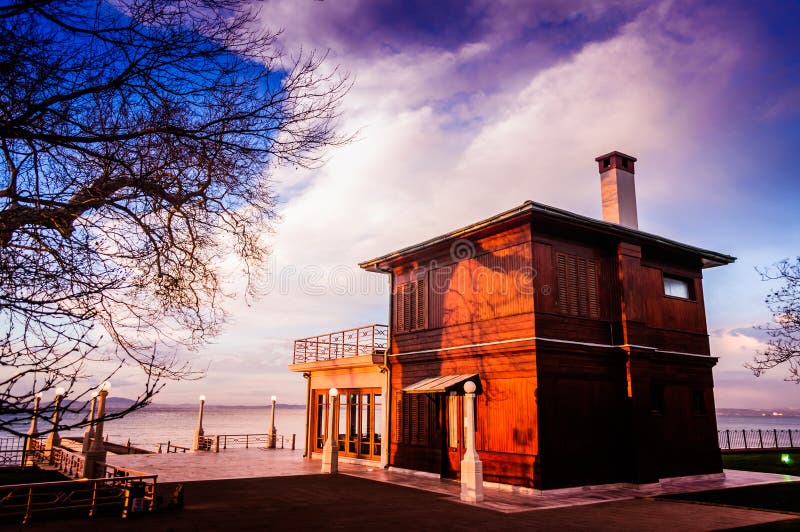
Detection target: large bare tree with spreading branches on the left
<box><xmin>0</xmin><ymin>0</ymin><xmax>349</xmax><ymax>434</ymax></box>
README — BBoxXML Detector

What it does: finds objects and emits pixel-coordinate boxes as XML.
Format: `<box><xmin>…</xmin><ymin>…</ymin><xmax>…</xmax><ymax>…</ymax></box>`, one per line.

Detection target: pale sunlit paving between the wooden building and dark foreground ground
<box><xmin>108</xmin><ymin>448</ymin><xmax>800</xmax><ymax>513</ymax></box>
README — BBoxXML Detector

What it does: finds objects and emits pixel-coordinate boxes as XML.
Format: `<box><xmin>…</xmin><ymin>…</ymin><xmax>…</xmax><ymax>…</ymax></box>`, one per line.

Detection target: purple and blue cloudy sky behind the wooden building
<box><xmin>115</xmin><ymin>0</ymin><xmax>800</xmax><ymax>408</ymax></box>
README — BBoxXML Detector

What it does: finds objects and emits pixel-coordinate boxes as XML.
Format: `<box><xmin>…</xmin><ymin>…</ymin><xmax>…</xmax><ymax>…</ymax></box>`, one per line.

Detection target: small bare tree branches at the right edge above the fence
<box><xmin>747</xmin><ymin>257</ymin><xmax>800</xmax><ymax>383</ymax></box>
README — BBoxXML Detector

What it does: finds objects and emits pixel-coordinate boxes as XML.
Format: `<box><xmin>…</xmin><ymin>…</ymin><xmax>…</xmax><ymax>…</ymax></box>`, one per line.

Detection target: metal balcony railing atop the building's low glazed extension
<box><xmin>294</xmin><ymin>325</ymin><xmax>389</xmax><ymax>364</ymax></box>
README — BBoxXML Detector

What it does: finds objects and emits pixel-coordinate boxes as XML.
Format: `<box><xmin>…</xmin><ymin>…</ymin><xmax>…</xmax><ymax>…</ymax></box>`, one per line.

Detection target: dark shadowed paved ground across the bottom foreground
<box><xmin>24</xmin><ymin>475</ymin><xmax>798</xmax><ymax>532</ymax></box>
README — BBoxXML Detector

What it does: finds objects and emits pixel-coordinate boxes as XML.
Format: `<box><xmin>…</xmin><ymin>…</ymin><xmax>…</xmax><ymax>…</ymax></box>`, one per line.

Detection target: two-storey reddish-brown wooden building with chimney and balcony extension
<box><xmin>290</xmin><ymin>152</ymin><xmax>735</xmax><ymax>489</ymax></box>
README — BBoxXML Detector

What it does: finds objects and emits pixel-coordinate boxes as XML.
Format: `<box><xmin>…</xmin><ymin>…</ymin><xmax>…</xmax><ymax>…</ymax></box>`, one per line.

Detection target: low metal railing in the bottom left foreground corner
<box><xmin>0</xmin><ymin>475</ymin><xmax>158</xmax><ymax>524</ymax></box>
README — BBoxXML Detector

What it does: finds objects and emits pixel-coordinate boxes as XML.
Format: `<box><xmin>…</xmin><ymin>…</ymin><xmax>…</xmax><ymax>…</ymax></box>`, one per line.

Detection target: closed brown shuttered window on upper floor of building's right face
<box><xmin>556</xmin><ymin>253</ymin><xmax>600</xmax><ymax>318</ymax></box>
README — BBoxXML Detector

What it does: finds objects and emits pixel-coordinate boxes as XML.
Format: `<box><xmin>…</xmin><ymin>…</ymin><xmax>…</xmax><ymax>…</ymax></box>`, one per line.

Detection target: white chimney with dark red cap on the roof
<box><xmin>595</xmin><ymin>151</ymin><xmax>639</xmax><ymax>229</ymax></box>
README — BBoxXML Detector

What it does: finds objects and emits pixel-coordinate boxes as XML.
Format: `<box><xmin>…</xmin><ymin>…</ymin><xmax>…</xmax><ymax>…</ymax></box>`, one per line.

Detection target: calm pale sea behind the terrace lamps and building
<box><xmin>1</xmin><ymin>405</ymin><xmax>800</xmax><ymax>451</ymax></box>
